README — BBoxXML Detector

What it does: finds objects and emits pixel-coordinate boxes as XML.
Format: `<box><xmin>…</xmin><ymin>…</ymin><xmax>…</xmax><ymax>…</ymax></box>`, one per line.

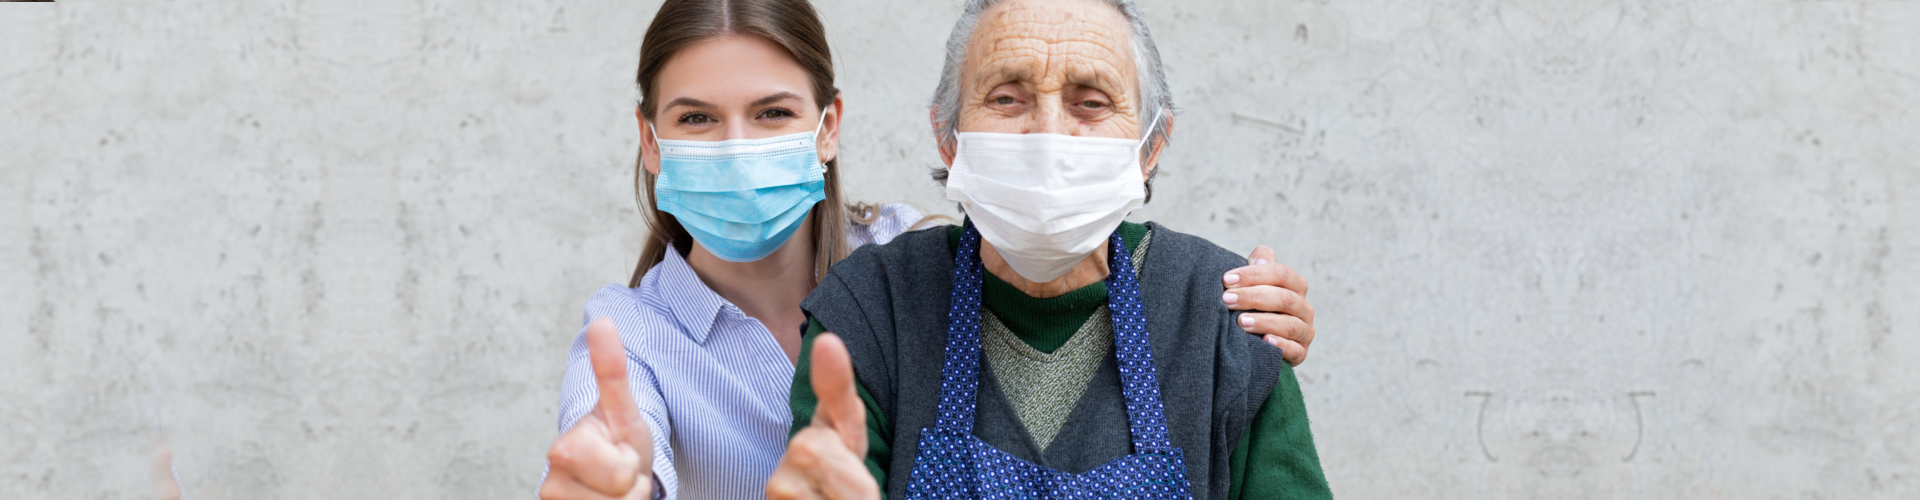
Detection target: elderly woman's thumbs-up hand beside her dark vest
<box><xmin>766</xmin><ymin>333</ymin><xmax>879</xmax><ymax>500</ymax></box>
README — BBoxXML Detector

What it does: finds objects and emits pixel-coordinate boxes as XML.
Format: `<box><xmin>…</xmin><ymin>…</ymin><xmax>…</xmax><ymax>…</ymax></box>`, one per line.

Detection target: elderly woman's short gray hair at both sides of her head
<box><xmin>929</xmin><ymin>0</ymin><xmax>1173</xmax><ymax>200</ymax></box>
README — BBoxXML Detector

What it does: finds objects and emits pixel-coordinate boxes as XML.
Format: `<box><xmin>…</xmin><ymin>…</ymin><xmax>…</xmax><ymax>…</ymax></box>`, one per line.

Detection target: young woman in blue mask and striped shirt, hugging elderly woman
<box><xmin>540</xmin><ymin>0</ymin><xmax>1311</xmax><ymax>498</ymax></box>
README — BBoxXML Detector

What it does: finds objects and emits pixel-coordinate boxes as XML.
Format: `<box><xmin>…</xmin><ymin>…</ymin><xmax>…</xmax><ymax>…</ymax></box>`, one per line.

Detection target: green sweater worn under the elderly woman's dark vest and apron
<box><xmin>789</xmin><ymin>223</ymin><xmax>1332</xmax><ymax>498</ymax></box>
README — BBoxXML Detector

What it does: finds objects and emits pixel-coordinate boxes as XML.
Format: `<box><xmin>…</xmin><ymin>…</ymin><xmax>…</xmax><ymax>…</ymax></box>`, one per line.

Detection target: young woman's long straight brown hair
<box><xmin>628</xmin><ymin>0</ymin><xmax>848</xmax><ymax>287</ymax></box>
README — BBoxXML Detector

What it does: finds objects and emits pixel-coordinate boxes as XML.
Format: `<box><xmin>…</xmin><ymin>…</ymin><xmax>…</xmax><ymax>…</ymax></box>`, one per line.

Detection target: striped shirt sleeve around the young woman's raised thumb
<box><xmin>541</xmin><ymin>308</ymin><xmax>680</xmax><ymax>498</ymax></box>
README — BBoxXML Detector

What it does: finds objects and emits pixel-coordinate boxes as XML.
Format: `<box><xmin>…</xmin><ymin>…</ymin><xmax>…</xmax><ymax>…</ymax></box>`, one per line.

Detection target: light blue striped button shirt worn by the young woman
<box><xmin>541</xmin><ymin>204</ymin><xmax>922</xmax><ymax>498</ymax></box>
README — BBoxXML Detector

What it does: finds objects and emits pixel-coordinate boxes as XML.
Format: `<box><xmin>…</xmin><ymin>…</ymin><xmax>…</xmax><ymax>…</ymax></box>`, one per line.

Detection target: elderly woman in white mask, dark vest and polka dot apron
<box><xmin>766</xmin><ymin>0</ymin><xmax>1331</xmax><ymax>498</ymax></box>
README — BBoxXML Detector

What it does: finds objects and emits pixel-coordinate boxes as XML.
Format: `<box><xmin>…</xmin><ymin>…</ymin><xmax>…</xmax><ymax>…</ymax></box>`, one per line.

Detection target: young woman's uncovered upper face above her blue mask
<box><xmin>636</xmin><ymin>35</ymin><xmax>841</xmax><ymax>175</ymax></box>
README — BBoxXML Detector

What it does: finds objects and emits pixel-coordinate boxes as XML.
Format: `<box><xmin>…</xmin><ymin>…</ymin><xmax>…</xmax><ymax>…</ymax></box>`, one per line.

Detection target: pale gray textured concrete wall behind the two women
<box><xmin>0</xmin><ymin>0</ymin><xmax>1920</xmax><ymax>498</ymax></box>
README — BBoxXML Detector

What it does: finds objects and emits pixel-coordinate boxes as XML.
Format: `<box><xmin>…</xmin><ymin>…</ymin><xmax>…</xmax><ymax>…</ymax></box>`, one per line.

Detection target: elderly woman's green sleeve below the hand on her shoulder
<box><xmin>1227</xmin><ymin>367</ymin><xmax>1332</xmax><ymax>498</ymax></box>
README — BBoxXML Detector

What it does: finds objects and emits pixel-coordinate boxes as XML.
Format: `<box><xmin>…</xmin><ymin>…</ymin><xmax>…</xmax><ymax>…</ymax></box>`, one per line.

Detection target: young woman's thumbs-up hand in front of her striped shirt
<box><xmin>540</xmin><ymin>317</ymin><xmax>653</xmax><ymax>500</ymax></box>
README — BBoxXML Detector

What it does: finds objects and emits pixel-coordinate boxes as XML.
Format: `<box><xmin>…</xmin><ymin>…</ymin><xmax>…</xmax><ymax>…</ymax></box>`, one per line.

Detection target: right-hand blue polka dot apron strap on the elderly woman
<box><xmin>1106</xmin><ymin>231</ymin><xmax>1173</xmax><ymax>454</ymax></box>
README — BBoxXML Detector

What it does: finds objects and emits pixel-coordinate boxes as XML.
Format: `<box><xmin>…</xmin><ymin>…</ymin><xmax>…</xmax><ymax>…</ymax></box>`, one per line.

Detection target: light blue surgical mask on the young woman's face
<box><xmin>653</xmin><ymin>115</ymin><xmax>828</xmax><ymax>262</ymax></box>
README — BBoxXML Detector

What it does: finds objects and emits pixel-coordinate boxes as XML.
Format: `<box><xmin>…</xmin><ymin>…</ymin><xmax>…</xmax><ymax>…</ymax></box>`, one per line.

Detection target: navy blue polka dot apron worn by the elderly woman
<box><xmin>906</xmin><ymin>223</ymin><xmax>1192</xmax><ymax>498</ymax></box>
